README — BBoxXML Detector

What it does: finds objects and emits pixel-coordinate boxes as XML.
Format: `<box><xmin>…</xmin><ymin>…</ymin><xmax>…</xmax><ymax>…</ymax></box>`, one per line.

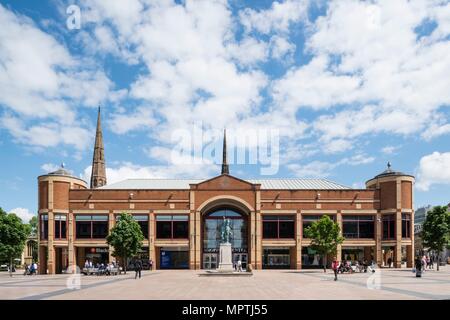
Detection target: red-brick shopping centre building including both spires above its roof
<box><xmin>38</xmin><ymin>112</ymin><xmax>414</xmax><ymax>274</ymax></box>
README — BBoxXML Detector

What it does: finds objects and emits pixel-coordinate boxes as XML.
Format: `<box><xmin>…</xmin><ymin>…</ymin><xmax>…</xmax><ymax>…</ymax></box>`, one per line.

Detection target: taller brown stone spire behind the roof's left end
<box><xmin>91</xmin><ymin>106</ymin><xmax>106</xmax><ymax>189</ymax></box>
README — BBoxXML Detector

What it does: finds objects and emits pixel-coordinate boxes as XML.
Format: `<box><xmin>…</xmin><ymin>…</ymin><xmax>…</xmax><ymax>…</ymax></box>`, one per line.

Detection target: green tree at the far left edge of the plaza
<box><xmin>0</xmin><ymin>208</ymin><xmax>31</xmax><ymax>277</ymax></box>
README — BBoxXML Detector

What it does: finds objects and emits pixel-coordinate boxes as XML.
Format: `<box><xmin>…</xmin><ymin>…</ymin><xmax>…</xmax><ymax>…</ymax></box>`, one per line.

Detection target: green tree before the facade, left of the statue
<box><xmin>106</xmin><ymin>212</ymin><xmax>144</xmax><ymax>273</ymax></box>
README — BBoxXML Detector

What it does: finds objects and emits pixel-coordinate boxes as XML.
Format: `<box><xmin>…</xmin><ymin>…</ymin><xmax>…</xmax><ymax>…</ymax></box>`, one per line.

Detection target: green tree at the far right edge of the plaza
<box><xmin>422</xmin><ymin>206</ymin><xmax>450</xmax><ymax>271</ymax></box>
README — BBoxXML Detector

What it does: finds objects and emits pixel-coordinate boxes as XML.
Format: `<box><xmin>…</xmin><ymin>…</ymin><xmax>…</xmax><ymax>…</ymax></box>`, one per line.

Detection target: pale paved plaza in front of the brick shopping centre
<box><xmin>0</xmin><ymin>266</ymin><xmax>450</xmax><ymax>300</ymax></box>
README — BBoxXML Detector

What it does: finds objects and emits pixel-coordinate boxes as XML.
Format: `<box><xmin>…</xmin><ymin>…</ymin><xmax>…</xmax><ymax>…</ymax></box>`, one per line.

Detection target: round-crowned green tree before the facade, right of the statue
<box><xmin>305</xmin><ymin>215</ymin><xmax>344</xmax><ymax>272</ymax></box>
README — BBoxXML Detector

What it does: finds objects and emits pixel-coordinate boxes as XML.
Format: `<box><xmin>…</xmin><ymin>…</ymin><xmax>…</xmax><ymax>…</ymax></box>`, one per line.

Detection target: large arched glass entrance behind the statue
<box><xmin>202</xmin><ymin>205</ymin><xmax>249</xmax><ymax>269</ymax></box>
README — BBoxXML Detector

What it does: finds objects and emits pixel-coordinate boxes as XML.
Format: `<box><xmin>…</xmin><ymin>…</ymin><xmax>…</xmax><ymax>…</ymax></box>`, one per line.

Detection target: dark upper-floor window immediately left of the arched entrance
<box><xmin>156</xmin><ymin>215</ymin><xmax>189</xmax><ymax>239</ymax></box>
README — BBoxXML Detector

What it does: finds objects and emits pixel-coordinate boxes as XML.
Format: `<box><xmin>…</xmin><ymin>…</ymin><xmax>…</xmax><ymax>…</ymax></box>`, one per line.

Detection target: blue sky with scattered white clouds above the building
<box><xmin>0</xmin><ymin>0</ymin><xmax>450</xmax><ymax>219</ymax></box>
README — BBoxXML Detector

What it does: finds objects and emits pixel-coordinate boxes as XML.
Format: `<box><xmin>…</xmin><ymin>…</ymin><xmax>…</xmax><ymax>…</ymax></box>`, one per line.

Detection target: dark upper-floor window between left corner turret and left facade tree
<box><xmin>75</xmin><ymin>215</ymin><xmax>108</xmax><ymax>239</ymax></box>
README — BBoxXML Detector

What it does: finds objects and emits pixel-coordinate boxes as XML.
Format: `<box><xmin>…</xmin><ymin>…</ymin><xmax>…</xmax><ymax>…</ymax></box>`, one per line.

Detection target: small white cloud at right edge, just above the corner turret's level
<box><xmin>416</xmin><ymin>152</ymin><xmax>450</xmax><ymax>191</ymax></box>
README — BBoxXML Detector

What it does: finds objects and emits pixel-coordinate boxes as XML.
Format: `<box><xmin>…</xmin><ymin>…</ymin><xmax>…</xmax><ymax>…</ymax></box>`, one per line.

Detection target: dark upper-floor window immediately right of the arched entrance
<box><xmin>263</xmin><ymin>216</ymin><xmax>295</xmax><ymax>239</ymax></box>
